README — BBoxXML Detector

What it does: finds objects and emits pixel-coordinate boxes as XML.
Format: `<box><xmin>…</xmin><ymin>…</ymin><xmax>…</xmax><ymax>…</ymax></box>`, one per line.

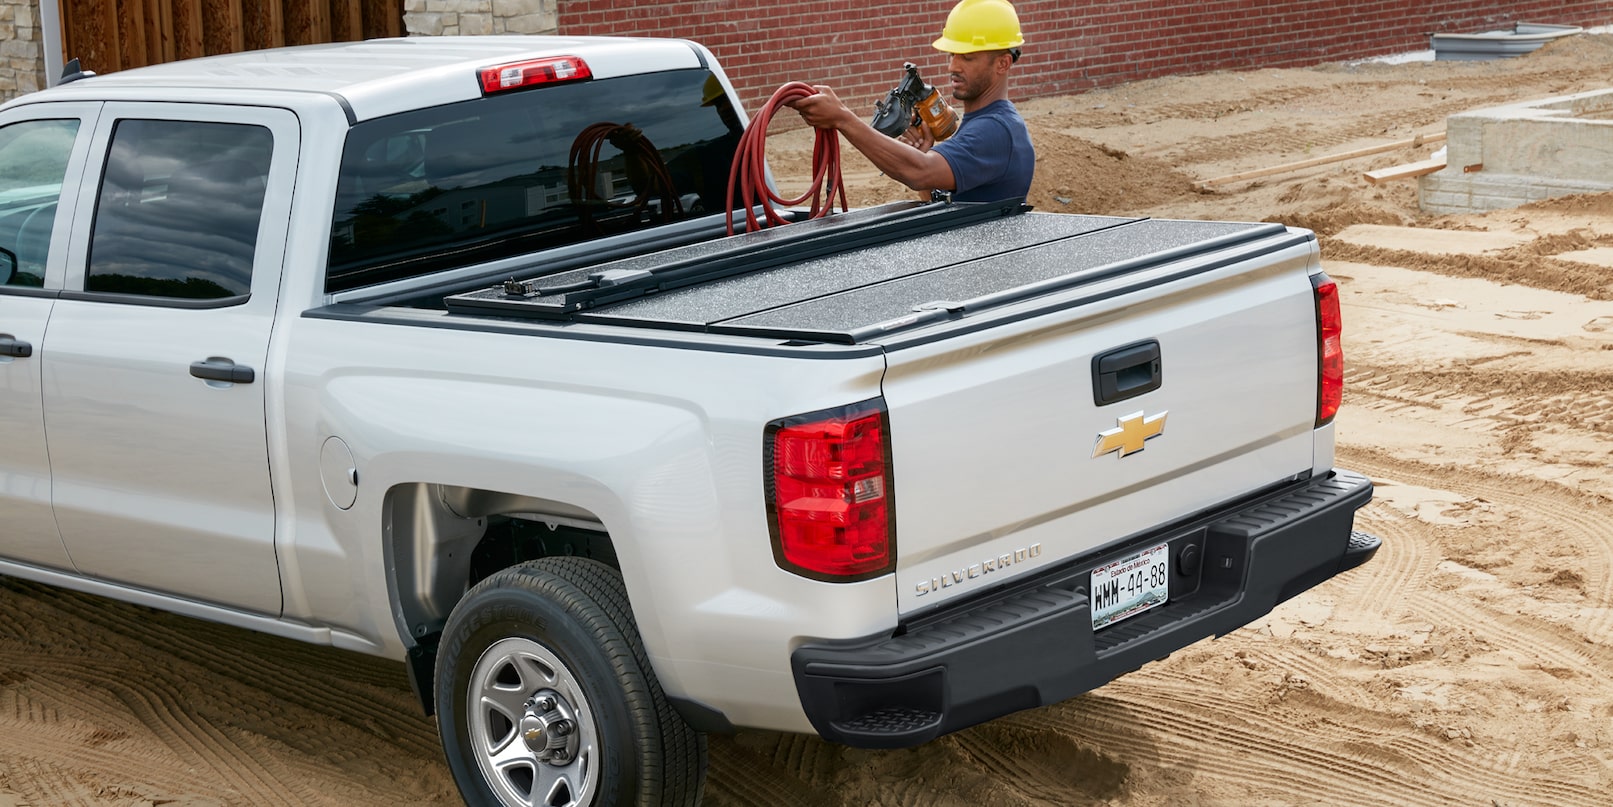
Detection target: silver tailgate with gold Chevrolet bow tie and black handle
<box><xmin>884</xmin><ymin>221</ymin><xmax>1318</xmax><ymax>613</ymax></box>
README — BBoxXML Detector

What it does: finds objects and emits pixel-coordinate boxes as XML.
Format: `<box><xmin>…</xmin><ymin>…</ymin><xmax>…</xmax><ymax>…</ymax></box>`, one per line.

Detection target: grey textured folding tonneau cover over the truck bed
<box><xmin>445</xmin><ymin>202</ymin><xmax>1310</xmax><ymax>344</ymax></box>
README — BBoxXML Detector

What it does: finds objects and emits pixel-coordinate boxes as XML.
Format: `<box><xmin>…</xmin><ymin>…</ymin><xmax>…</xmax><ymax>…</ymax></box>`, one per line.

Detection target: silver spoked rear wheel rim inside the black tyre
<box><xmin>465</xmin><ymin>638</ymin><xmax>600</xmax><ymax>807</ymax></box>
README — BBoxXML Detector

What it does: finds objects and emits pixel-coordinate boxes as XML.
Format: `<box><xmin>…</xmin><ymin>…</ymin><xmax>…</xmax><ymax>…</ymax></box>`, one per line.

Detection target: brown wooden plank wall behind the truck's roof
<box><xmin>61</xmin><ymin>0</ymin><xmax>403</xmax><ymax>73</ymax></box>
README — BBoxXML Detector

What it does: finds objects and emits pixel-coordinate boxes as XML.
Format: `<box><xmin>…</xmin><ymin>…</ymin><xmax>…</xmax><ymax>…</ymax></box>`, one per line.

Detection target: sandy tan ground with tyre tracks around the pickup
<box><xmin>0</xmin><ymin>37</ymin><xmax>1613</xmax><ymax>807</ymax></box>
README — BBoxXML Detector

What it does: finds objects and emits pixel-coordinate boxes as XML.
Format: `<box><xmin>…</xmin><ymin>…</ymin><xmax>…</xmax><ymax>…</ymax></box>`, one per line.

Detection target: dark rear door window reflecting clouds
<box><xmin>84</xmin><ymin>119</ymin><xmax>274</xmax><ymax>300</ymax></box>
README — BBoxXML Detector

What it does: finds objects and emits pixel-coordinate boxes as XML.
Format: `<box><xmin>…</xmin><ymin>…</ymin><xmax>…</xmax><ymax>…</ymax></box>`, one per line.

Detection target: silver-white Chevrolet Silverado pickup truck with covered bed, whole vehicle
<box><xmin>0</xmin><ymin>37</ymin><xmax>1379</xmax><ymax>805</ymax></box>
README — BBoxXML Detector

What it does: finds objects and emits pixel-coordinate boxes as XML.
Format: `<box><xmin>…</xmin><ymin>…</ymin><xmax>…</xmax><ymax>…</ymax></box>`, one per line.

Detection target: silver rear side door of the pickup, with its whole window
<box><xmin>40</xmin><ymin>103</ymin><xmax>298</xmax><ymax>615</ymax></box>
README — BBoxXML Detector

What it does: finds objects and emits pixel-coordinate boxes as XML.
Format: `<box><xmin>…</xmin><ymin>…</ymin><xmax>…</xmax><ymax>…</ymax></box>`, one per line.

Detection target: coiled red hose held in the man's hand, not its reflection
<box><xmin>727</xmin><ymin>81</ymin><xmax>850</xmax><ymax>236</ymax></box>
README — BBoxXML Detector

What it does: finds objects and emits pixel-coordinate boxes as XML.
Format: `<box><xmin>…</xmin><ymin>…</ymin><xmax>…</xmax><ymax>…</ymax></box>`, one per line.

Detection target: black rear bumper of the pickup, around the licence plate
<box><xmin>790</xmin><ymin>470</ymin><xmax>1381</xmax><ymax>747</ymax></box>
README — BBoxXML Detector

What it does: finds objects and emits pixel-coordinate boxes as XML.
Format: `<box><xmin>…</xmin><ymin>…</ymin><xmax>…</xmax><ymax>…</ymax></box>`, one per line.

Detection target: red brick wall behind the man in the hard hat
<box><xmin>560</xmin><ymin>0</ymin><xmax>1613</xmax><ymax>124</ymax></box>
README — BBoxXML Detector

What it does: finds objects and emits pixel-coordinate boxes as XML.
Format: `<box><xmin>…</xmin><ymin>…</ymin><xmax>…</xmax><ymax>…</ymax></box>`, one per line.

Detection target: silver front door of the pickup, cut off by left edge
<box><xmin>0</xmin><ymin>103</ymin><xmax>100</xmax><ymax>570</ymax></box>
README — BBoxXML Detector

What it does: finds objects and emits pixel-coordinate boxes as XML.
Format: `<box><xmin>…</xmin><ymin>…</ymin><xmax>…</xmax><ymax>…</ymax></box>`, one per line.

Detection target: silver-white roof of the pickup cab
<box><xmin>27</xmin><ymin>36</ymin><xmax>716</xmax><ymax>121</ymax></box>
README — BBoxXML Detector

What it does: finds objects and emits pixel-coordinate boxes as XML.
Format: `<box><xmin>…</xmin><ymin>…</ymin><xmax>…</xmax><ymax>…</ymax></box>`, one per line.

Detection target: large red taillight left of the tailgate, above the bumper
<box><xmin>766</xmin><ymin>404</ymin><xmax>895</xmax><ymax>583</ymax></box>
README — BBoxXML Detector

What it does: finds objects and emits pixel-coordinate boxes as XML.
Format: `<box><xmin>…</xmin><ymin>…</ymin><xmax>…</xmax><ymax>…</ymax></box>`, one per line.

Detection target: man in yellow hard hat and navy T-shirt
<box><xmin>790</xmin><ymin>0</ymin><xmax>1036</xmax><ymax>202</ymax></box>
